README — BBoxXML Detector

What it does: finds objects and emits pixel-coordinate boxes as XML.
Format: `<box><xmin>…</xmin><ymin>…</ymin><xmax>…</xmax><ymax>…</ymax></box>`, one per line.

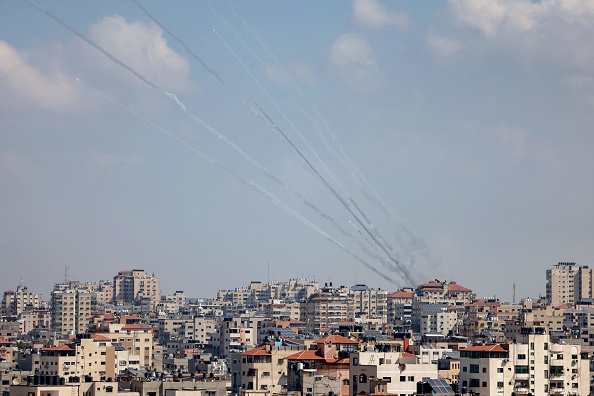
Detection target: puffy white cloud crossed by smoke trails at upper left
<box><xmin>89</xmin><ymin>15</ymin><xmax>190</xmax><ymax>89</ymax></box>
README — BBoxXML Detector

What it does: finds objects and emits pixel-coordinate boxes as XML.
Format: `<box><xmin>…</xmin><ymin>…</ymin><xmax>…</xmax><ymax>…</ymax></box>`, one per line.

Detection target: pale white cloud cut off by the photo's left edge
<box><xmin>0</xmin><ymin>40</ymin><xmax>78</xmax><ymax>112</ymax></box>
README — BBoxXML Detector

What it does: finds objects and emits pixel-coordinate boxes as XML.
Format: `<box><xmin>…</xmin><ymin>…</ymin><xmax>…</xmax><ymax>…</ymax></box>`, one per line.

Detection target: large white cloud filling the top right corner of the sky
<box><xmin>448</xmin><ymin>0</ymin><xmax>594</xmax><ymax>69</ymax></box>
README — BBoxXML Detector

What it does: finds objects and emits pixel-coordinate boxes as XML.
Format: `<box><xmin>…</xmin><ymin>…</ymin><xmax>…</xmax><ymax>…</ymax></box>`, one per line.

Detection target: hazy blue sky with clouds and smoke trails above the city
<box><xmin>0</xmin><ymin>0</ymin><xmax>594</xmax><ymax>301</ymax></box>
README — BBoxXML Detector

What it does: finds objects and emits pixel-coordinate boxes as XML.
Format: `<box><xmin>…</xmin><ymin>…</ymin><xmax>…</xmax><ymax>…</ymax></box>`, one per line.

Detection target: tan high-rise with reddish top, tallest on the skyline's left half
<box><xmin>113</xmin><ymin>269</ymin><xmax>160</xmax><ymax>306</ymax></box>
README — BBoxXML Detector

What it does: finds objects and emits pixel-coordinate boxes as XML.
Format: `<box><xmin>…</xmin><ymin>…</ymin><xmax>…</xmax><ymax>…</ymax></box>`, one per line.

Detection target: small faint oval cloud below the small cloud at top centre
<box><xmin>330</xmin><ymin>33</ymin><xmax>385</xmax><ymax>93</ymax></box>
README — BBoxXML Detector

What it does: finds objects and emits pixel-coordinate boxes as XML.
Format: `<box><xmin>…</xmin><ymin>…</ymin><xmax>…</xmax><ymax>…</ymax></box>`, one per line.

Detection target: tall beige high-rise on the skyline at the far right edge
<box><xmin>546</xmin><ymin>263</ymin><xmax>594</xmax><ymax>306</ymax></box>
